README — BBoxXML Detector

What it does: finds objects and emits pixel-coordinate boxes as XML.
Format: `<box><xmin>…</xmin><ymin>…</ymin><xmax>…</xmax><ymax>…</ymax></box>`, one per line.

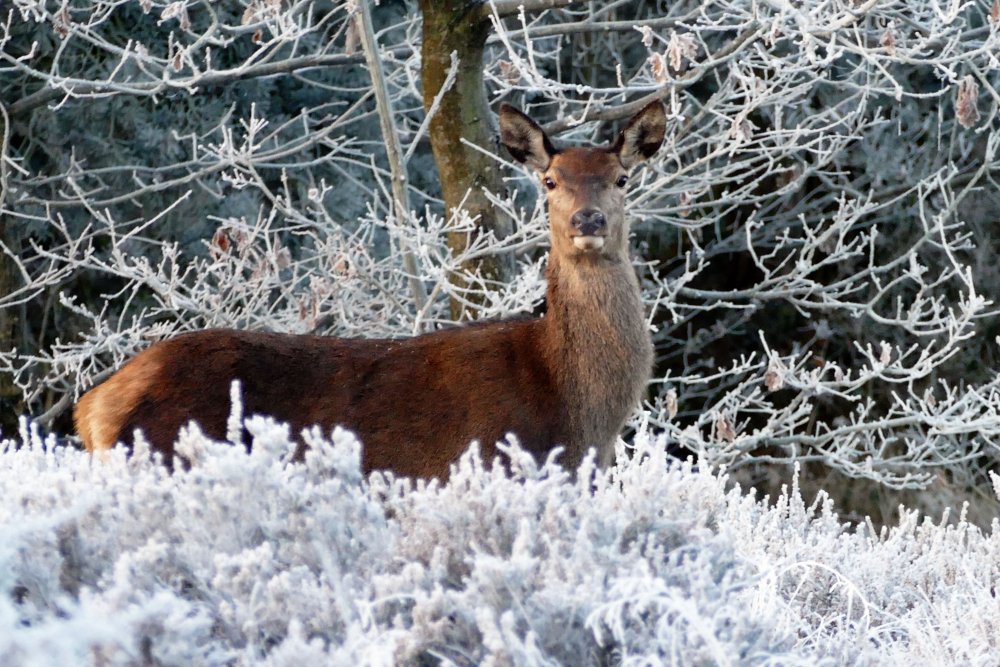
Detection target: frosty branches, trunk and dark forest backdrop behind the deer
<box><xmin>0</xmin><ymin>0</ymin><xmax>1000</xmax><ymax>522</ymax></box>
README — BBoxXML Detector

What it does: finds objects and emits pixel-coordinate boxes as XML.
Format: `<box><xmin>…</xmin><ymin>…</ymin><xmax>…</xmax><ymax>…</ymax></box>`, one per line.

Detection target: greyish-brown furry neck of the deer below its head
<box><xmin>542</xmin><ymin>252</ymin><xmax>653</xmax><ymax>465</ymax></box>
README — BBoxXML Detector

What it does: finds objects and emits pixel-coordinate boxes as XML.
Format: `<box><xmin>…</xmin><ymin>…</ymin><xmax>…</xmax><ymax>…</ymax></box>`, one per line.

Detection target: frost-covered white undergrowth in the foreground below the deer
<box><xmin>0</xmin><ymin>418</ymin><xmax>1000</xmax><ymax>667</ymax></box>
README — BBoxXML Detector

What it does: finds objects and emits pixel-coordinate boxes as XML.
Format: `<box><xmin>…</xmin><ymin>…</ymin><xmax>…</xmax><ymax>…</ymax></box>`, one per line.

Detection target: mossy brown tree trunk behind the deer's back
<box><xmin>420</xmin><ymin>0</ymin><xmax>513</xmax><ymax>320</ymax></box>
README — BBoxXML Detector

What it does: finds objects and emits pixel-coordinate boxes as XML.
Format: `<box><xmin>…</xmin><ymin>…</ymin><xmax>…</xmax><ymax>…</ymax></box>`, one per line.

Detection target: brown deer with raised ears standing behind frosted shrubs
<box><xmin>74</xmin><ymin>102</ymin><xmax>665</xmax><ymax>479</ymax></box>
